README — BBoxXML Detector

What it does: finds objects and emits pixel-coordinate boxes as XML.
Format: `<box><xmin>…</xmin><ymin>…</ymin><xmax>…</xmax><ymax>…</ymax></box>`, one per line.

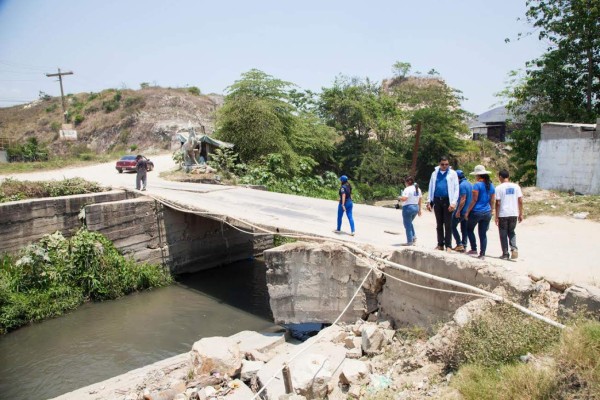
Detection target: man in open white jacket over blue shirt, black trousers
<box><xmin>427</xmin><ymin>156</ymin><xmax>459</xmax><ymax>251</ymax></box>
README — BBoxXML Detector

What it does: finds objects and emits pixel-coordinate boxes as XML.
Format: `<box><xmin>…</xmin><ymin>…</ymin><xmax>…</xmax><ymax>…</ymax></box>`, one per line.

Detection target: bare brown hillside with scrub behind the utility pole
<box><xmin>0</xmin><ymin>87</ymin><xmax>223</xmax><ymax>156</ymax></box>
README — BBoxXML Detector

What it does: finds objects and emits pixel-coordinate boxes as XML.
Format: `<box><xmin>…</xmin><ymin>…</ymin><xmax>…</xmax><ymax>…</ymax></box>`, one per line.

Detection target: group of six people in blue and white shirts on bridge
<box><xmin>335</xmin><ymin>156</ymin><xmax>523</xmax><ymax>260</ymax></box>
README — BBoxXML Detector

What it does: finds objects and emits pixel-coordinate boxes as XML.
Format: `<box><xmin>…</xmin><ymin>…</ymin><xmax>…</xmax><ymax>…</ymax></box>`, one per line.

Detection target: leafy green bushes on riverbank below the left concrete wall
<box><xmin>0</xmin><ymin>228</ymin><xmax>172</xmax><ymax>334</ymax></box>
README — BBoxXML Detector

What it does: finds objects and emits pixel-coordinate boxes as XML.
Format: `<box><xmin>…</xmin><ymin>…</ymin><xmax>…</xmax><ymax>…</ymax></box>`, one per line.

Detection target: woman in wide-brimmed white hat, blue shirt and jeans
<box><xmin>465</xmin><ymin>165</ymin><xmax>496</xmax><ymax>260</ymax></box>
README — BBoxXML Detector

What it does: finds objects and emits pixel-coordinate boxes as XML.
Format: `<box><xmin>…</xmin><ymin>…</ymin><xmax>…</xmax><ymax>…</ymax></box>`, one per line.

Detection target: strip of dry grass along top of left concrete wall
<box><xmin>0</xmin><ymin>178</ymin><xmax>107</xmax><ymax>203</ymax></box>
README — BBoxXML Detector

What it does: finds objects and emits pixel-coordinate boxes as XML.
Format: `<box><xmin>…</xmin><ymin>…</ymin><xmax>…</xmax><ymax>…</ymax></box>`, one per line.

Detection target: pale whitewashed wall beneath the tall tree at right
<box><xmin>536</xmin><ymin>123</ymin><xmax>600</xmax><ymax>194</ymax></box>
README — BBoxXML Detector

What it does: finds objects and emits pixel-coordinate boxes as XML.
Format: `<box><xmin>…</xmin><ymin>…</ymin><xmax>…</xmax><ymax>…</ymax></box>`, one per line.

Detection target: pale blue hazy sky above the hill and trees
<box><xmin>0</xmin><ymin>0</ymin><xmax>545</xmax><ymax>114</ymax></box>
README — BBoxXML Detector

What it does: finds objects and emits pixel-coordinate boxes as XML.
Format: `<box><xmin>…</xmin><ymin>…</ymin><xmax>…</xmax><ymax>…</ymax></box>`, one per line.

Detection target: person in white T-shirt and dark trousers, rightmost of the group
<box><xmin>496</xmin><ymin>170</ymin><xmax>523</xmax><ymax>260</ymax></box>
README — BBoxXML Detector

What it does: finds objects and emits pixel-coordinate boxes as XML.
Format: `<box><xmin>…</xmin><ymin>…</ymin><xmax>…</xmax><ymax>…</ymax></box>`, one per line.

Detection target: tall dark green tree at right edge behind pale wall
<box><xmin>507</xmin><ymin>0</ymin><xmax>600</xmax><ymax>184</ymax></box>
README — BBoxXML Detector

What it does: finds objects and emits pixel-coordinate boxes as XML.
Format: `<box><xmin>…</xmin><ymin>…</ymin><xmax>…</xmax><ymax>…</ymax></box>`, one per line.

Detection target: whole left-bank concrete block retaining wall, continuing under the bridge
<box><xmin>0</xmin><ymin>191</ymin><xmax>273</xmax><ymax>274</ymax></box>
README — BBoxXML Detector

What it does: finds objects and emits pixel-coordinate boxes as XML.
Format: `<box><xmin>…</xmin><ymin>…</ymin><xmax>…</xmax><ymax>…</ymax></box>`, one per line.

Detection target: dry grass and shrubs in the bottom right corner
<box><xmin>446</xmin><ymin>306</ymin><xmax>600</xmax><ymax>400</ymax></box>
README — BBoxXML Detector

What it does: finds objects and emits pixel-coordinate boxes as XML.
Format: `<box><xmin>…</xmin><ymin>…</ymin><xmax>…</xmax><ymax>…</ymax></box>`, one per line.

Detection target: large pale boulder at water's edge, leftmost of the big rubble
<box><xmin>192</xmin><ymin>336</ymin><xmax>242</xmax><ymax>376</ymax></box>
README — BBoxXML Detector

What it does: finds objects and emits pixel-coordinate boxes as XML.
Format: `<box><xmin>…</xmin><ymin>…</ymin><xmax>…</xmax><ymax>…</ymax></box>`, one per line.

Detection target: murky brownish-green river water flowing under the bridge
<box><xmin>0</xmin><ymin>260</ymin><xmax>278</xmax><ymax>399</ymax></box>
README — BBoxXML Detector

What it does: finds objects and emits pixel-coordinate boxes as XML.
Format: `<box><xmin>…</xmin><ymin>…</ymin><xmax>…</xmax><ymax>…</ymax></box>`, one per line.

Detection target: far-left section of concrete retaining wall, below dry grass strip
<box><xmin>0</xmin><ymin>190</ymin><xmax>127</xmax><ymax>253</ymax></box>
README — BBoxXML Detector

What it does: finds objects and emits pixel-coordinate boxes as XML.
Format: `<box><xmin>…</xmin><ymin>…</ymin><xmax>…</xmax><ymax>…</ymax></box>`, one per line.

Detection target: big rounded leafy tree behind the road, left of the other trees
<box><xmin>217</xmin><ymin>69</ymin><xmax>336</xmax><ymax>174</ymax></box>
